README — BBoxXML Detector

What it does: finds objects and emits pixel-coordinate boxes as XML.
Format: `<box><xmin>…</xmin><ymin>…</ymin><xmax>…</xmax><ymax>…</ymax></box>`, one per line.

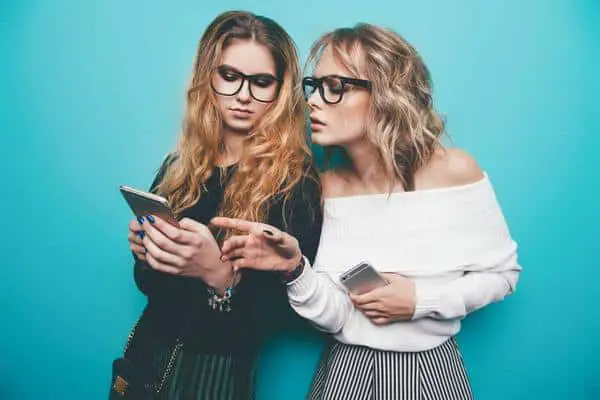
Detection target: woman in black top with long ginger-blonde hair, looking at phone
<box><xmin>118</xmin><ymin>12</ymin><xmax>322</xmax><ymax>400</ymax></box>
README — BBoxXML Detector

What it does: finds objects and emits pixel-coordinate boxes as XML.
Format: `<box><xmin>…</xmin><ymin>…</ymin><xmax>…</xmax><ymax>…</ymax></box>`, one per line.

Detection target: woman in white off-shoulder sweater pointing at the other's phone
<box><xmin>213</xmin><ymin>24</ymin><xmax>520</xmax><ymax>400</ymax></box>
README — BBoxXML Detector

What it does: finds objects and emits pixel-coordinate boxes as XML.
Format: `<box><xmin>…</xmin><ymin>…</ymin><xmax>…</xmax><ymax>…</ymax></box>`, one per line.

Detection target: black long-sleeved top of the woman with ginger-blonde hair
<box><xmin>135</xmin><ymin>156</ymin><xmax>323</xmax><ymax>355</ymax></box>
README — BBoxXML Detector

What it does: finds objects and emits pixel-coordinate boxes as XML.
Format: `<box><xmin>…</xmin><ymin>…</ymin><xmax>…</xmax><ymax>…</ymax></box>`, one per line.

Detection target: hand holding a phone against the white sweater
<box><xmin>350</xmin><ymin>274</ymin><xmax>416</xmax><ymax>325</ymax></box>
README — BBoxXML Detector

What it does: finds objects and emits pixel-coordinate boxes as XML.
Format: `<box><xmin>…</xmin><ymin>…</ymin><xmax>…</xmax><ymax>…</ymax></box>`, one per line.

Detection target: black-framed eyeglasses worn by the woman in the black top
<box><xmin>211</xmin><ymin>65</ymin><xmax>282</xmax><ymax>103</ymax></box>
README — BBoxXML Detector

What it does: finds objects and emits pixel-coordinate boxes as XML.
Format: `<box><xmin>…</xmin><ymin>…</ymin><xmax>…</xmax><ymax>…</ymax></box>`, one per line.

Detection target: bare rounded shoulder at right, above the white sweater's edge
<box><xmin>418</xmin><ymin>148</ymin><xmax>484</xmax><ymax>187</ymax></box>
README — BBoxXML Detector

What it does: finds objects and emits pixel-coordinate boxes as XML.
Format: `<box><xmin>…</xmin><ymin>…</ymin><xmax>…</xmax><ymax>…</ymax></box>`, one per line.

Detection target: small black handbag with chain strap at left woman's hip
<box><xmin>109</xmin><ymin>319</ymin><xmax>183</xmax><ymax>400</ymax></box>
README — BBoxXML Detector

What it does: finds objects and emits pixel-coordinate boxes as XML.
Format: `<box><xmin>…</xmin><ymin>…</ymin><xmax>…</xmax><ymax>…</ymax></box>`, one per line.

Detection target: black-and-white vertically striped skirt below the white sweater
<box><xmin>309</xmin><ymin>338</ymin><xmax>473</xmax><ymax>400</ymax></box>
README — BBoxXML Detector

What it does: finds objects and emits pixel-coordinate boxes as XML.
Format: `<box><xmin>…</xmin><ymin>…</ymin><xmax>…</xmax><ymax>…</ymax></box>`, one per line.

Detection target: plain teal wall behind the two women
<box><xmin>0</xmin><ymin>0</ymin><xmax>600</xmax><ymax>400</ymax></box>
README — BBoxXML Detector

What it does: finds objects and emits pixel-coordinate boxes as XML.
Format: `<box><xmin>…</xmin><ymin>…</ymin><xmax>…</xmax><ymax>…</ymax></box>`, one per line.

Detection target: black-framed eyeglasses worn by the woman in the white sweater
<box><xmin>302</xmin><ymin>75</ymin><xmax>372</xmax><ymax>104</ymax></box>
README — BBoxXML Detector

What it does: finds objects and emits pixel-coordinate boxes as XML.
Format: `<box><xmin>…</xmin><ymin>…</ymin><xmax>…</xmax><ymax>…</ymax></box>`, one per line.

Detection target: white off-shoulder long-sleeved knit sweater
<box><xmin>288</xmin><ymin>174</ymin><xmax>521</xmax><ymax>352</ymax></box>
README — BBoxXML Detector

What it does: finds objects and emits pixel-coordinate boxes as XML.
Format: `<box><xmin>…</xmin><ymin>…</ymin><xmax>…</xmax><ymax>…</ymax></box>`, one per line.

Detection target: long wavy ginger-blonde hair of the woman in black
<box><xmin>157</xmin><ymin>11</ymin><xmax>311</xmax><ymax>222</ymax></box>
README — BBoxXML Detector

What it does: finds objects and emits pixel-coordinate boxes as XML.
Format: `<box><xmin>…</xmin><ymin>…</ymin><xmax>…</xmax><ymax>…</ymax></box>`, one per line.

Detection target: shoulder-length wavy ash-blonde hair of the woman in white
<box><xmin>307</xmin><ymin>24</ymin><xmax>445</xmax><ymax>190</ymax></box>
